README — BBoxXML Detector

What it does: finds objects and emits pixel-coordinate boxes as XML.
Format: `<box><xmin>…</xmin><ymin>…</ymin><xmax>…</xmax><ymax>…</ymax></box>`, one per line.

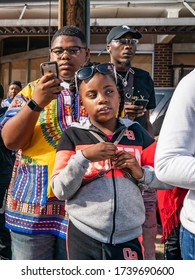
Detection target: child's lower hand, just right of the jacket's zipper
<box><xmin>114</xmin><ymin>151</ymin><xmax>143</xmax><ymax>180</ymax></box>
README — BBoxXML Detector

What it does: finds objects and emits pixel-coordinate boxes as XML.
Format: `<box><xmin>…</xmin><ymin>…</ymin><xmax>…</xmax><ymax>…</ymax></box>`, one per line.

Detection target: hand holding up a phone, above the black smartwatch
<box><xmin>32</xmin><ymin>73</ymin><xmax>63</xmax><ymax>108</ymax></box>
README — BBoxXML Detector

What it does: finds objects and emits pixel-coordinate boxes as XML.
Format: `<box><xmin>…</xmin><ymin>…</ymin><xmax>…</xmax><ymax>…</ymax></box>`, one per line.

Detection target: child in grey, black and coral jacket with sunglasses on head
<box><xmin>52</xmin><ymin>63</ymin><xmax>170</xmax><ymax>260</ymax></box>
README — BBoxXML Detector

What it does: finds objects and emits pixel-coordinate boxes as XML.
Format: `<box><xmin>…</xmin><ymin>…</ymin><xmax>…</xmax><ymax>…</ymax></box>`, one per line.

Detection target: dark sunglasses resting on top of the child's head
<box><xmin>75</xmin><ymin>63</ymin><xmax>117</xmax><ymax>92</ymax></box>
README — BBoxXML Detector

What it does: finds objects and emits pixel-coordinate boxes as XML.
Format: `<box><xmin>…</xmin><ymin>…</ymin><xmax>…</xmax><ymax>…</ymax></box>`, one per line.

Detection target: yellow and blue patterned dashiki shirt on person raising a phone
<box><xmin>1</xmin><ymin>80</ymin><xmax>86</xmax><ymax>238</ymax></box>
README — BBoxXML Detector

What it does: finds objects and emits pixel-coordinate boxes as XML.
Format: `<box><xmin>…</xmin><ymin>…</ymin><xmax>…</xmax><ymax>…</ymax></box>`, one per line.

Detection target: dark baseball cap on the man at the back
<box><xmin>106</xmin><ymin>25</ymin><xmax>142</xmax><ymax>44</ymax></box>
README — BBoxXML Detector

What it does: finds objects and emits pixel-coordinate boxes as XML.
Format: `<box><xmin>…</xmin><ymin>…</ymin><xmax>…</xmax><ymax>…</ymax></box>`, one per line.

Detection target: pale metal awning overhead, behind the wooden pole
<box><xmin>0</xmin><ymin>0</ymin><xmax>195</xmax><ymax>38</ymax></box>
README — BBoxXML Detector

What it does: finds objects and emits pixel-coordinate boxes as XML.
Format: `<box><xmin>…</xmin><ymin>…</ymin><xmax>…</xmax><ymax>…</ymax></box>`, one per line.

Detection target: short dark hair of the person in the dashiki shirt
<box><xmin>51</xmin><ymin>25</ymin><xmax>86</xmax><ymax>45</ymax></box>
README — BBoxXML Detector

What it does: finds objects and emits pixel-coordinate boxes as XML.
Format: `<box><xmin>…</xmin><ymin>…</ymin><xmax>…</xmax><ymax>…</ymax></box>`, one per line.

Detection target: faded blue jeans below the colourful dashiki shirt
<box><xmin>11</xmin><ymin>231</ymin><xmax>67</xmax><ymax>260</ymax></box>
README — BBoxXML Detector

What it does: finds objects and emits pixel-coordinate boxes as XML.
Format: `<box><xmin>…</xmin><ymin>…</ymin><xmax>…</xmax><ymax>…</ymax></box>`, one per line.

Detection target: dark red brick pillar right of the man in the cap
<box><xmin>154</xmin><ymin>44</ymin><xmax>173</xmax><ymax>87</ymax></box>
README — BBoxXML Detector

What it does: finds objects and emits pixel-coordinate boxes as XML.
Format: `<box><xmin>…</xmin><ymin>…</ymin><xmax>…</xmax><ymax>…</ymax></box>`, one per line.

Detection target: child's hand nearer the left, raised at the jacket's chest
<box><xmin>82</xmin><ymin>142</ymin><xmax>117</xmax><ymax>162</ymax></box>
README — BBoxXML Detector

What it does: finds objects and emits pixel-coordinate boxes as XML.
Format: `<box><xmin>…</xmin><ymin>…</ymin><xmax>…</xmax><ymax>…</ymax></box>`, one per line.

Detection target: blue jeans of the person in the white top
<box><xmin>180</xmin><ymin>225</ymin><xmax>195</xmax><ymax>260</ymax></box>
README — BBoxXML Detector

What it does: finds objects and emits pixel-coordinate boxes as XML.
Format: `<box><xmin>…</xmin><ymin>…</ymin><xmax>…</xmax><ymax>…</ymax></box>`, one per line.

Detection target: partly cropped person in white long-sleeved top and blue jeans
<box><xmin>155</xmin><ymin>69</ymin><xmax>195</xmax><ymax>260</ymax></box>
